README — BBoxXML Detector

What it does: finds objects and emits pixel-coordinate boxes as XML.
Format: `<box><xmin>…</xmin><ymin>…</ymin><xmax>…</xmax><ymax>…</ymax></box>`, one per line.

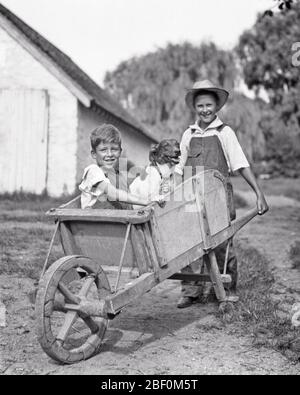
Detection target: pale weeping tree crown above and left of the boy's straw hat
<box><xmin>104</xmin><ymin>43</ymin><xmax>237</xmax><ymax>138</ymax></box>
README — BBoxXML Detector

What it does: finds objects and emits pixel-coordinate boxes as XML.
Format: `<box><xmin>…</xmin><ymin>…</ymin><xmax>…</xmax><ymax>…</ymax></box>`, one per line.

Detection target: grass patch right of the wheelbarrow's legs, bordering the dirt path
<box><xmin>220</xmin><ymin>245</ymin><xmax>300</xmax><ymax>361</ymax></box>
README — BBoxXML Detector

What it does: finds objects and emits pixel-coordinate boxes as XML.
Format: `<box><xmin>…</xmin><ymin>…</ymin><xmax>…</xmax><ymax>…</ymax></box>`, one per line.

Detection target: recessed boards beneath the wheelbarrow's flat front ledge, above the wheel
<box><xmin>59</xmin><ymin>221</ymin><xmax>155</xmax><ymax>275</ymax></box>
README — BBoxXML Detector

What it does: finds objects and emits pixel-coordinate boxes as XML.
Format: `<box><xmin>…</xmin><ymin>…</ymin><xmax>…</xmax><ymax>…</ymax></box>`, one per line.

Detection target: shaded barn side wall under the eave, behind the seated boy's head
<box><xmin>77</xmin><ymin>103</ymin><xmax>152</xmax><ymax>187</ymax></box>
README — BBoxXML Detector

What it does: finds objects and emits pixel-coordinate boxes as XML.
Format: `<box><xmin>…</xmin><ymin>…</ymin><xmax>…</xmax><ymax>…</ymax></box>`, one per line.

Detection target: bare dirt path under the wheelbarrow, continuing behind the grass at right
<box><xmin>0</xmin><ymin>193</ymin><xmax>300</xmax><ymax>375</ymax></box>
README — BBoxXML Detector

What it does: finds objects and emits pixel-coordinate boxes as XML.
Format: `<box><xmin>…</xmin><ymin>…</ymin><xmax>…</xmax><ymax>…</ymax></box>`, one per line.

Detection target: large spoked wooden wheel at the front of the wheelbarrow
<box><xmin>36</xmin><ymin>256</ymin><xmax>111</xmax><ymax>364</ymax></box>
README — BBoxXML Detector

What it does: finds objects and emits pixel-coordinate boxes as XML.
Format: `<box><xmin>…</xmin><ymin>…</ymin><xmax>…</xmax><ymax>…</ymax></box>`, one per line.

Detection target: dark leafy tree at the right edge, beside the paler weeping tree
<box><xmin>237</xmin><ymin>1</ymin><xmax>300</xmax><ymax>176</ymax></box>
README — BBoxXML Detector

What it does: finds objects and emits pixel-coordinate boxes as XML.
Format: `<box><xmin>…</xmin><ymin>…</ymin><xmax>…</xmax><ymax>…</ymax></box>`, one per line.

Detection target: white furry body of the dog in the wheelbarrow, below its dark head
<box><xmin>129</xmin><ymin>164</ymin><xmax>174</xmax><ymax>209</ymax></box>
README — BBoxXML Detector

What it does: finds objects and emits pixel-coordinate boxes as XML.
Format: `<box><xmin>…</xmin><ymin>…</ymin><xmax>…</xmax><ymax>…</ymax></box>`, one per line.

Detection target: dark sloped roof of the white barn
<box><xmin>0</xmin><ymin>3</ymin><xmax>156</xmax><ymax>141</ymax></box>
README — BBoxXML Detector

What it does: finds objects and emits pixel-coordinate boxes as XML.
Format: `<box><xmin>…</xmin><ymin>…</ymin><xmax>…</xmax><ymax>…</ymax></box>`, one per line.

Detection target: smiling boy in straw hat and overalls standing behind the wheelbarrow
<box><xmin>175</xmin><ymin>80</ymin><xmax>269</xmax><ymax>308</ymax></box>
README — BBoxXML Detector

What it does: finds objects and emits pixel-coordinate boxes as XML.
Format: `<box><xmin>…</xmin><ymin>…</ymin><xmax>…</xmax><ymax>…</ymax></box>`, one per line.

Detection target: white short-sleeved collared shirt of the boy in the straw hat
<box><xmin>175</xmin><ymin>116</ymin><xmax>250</xmax><ymax>175</ymax></box>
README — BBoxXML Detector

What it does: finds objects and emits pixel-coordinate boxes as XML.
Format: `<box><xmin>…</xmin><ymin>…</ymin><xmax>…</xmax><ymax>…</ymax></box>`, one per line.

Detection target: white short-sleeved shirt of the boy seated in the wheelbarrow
<box><xmin>79</xmin><ymin>164</ymin><xmax>110</xmax><ymax>209</ymax></box>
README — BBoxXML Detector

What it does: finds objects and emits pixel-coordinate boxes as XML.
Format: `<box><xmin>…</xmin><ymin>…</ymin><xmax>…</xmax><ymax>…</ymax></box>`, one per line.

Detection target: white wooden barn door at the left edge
<box><xmin>0</xmin><ymin>89</ymin><xmax>49</xmax><ymax>194</ymax></box>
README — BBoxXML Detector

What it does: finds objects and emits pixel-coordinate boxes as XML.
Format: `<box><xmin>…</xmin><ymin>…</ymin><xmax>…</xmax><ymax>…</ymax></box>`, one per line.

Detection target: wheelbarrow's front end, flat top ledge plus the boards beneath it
<box><xmin>47</xmin><ymin>203</ymin><xmax>151</xmax><ymax>274</ymax></box>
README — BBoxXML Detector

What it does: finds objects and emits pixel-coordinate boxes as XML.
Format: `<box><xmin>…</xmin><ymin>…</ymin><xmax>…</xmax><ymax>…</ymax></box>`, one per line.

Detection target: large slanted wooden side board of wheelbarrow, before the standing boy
<box><xmin>154</xmin><ymin>171</ymin><xmax>230</xmax><ymax>262</ymax></box>
